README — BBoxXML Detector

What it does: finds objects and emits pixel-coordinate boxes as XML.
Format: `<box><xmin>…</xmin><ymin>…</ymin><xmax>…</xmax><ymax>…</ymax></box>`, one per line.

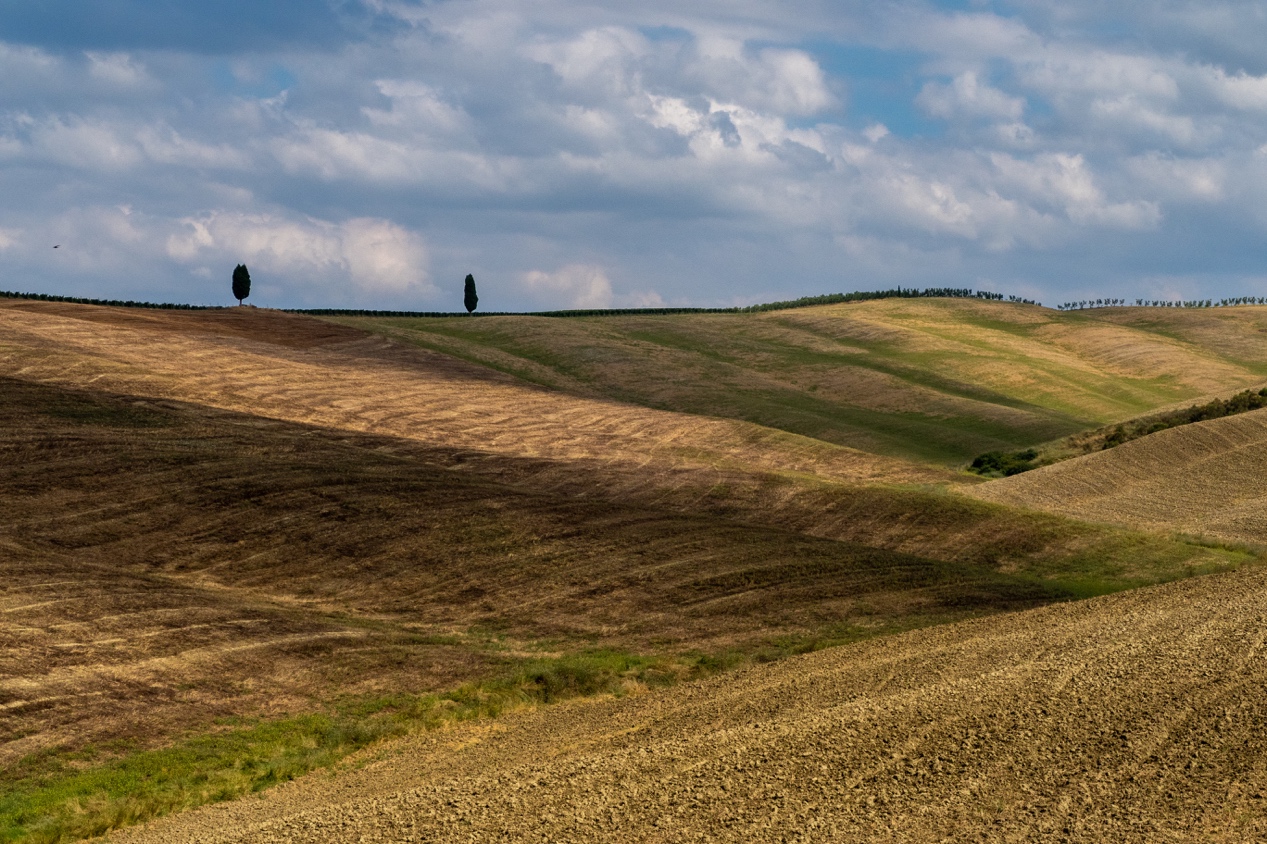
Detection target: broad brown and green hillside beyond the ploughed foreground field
<box><xmin>0</xmin><ymin>294</ymin><xmax>1263</xmax><ymax>840</ymax></box>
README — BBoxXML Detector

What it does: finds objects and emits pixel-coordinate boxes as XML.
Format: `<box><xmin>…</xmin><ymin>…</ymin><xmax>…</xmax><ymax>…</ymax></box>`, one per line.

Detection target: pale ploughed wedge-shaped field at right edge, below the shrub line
<box><xmin>968</xmin><ymin>411</ymin><xmax>1267</xmax><ymax>546</ymax></box>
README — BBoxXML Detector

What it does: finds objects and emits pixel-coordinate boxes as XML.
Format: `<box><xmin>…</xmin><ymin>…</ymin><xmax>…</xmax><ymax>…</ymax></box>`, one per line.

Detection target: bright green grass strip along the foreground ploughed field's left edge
<box><xmin>0</xmin><ymin>651</ymin><xmax>741</xmax><ymax>844</ymax></box>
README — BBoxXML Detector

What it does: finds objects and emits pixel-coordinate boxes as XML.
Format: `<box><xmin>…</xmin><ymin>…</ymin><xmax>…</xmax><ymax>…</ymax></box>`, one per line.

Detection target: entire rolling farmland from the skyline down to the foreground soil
<box><xmin>0</xmin><ymin>299</ymin><xmax>1267</xmax><ymax>841</ymax></box>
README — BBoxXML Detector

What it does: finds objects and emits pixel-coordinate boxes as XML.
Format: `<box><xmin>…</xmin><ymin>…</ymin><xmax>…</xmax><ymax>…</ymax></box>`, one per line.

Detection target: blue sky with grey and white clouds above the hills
<box><xmin>0</xmin><ymin>0</ymin><xmax>1267</xmax><ymax>310</ymax></box>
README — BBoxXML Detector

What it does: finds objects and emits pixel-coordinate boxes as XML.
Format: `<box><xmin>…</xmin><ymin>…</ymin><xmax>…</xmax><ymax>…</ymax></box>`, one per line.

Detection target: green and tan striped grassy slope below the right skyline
<box><xmin>331</xmin><ymin>299</ymin><xmax>1267</xmax><ymax>465</ymax></box>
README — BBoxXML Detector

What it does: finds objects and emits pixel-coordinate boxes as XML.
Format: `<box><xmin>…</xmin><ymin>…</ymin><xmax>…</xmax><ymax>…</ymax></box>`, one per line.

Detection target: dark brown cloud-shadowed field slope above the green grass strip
<box><xmin>0</xmin><ymin>378</ymin><xmax>1038</xmax><ymax>767</ymax></box>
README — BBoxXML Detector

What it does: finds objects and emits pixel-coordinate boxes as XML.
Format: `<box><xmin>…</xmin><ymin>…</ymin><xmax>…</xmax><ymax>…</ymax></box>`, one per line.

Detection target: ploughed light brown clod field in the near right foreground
<box><xmin>109</xmin><ymin>557</ymin><xmax>1267</xmax><ymax>844</ymax></box>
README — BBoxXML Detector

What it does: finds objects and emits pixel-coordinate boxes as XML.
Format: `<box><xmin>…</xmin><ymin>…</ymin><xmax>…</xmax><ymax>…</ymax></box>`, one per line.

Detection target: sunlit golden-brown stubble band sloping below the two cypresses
<box><xmin>0</xmin><ymin>302</ymin><xmax>950</xmax><ymax>483</ymax></box>
